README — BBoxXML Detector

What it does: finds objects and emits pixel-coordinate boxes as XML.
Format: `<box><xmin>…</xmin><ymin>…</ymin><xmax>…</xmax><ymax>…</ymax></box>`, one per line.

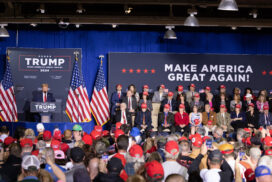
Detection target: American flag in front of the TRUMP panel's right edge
<box><xmin>66</xmin><ymin>60</ymin><xmax>92</xmax><ymax>123</ymax></box>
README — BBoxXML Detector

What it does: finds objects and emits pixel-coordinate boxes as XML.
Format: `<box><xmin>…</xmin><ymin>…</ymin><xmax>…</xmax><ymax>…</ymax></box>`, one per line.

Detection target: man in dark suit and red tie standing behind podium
<box><xmin>32</xmin><ymin>83</ymin><xmax>55</xmax><ymax>122</ymax></box>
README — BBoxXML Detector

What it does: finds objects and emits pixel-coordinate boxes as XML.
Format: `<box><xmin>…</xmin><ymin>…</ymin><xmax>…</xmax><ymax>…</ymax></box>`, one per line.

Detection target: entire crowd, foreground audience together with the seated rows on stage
<box><xmin>0</xmin><ymin>84</ymin><xmax>272</xmax><ymax>182</ymax></box>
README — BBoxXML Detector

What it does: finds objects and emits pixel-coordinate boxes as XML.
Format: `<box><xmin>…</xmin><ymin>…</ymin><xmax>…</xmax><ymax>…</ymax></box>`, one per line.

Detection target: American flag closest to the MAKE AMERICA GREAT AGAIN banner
<box><xmin>91</xmin><ymin>61</ymin><xmax>110</xmax><ymax>125</ymax></box>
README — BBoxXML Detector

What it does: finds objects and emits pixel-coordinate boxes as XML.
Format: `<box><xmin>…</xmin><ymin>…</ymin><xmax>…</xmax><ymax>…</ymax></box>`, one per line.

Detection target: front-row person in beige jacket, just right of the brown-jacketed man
<box><xmin>216</xmin><ymin>105</ymin><xmax>234</xmax><ymax>133</ymax></box>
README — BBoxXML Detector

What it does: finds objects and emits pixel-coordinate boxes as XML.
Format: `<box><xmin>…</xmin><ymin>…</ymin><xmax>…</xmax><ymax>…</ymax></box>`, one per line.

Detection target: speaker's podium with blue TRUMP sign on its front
<box><xmin>30</xmin><ymin>102</ymin><xmax>61</xmax><ymax>123</ymax></box>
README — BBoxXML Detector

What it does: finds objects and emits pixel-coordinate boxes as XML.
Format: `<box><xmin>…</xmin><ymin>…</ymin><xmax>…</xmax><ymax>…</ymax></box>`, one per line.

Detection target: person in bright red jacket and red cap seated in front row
<box><xmin>175</xmin><ymin>104</ymin><xmax>190</xmax><ymax>134</ymax></box>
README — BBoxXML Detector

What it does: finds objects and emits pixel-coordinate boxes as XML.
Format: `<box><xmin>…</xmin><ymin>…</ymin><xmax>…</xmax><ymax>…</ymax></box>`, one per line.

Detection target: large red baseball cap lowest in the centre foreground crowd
<box><xmin>145</xmin><ymin>160</ymin><xmax>164</xmax><ymax>179</ymax></box>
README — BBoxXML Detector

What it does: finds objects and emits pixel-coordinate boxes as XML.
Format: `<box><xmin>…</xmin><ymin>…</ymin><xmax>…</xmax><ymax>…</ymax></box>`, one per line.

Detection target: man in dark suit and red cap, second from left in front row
<box><xmin>135</xmin><ymin>103</ymin><xmax>152</xmax><ymax>138</ymax></box>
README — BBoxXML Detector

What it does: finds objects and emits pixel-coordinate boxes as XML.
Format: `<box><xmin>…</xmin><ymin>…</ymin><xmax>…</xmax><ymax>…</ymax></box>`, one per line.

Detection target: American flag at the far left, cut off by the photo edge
<box><xmin>0</xmin><ymin>60</ymin><xmax>18</xmax><ymax>122</ymax></box>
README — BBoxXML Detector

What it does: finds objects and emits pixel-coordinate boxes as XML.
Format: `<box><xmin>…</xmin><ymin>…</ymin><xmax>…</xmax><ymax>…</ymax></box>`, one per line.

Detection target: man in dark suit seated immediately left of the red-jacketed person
<box><xmin>158</xmin><ymin>104</ymin><xmax>175</xmax><ymax>133</ymax></box>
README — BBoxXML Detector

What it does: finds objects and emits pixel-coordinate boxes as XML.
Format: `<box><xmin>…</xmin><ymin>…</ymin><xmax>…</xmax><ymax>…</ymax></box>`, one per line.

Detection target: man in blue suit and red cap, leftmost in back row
<box><xmin>111</xmin><ymin>84</ymin><xmax>123</xmax><ymax>117</ymax></box>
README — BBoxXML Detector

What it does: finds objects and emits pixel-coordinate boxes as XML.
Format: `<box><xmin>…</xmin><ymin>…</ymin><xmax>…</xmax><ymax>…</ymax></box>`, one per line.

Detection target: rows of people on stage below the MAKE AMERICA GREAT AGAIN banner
<box><xmin>111</xmin><ymin>84</ymin><xmax>272</xmax><ymax>138</ymax></box>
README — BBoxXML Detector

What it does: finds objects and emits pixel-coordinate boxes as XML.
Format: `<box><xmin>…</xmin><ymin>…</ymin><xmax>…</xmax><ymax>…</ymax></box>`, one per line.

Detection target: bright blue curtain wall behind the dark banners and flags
<box><xmin>0</xmin><ymin>30</ymin><xmax>272</xmax><ymax>96</ymax></box>
